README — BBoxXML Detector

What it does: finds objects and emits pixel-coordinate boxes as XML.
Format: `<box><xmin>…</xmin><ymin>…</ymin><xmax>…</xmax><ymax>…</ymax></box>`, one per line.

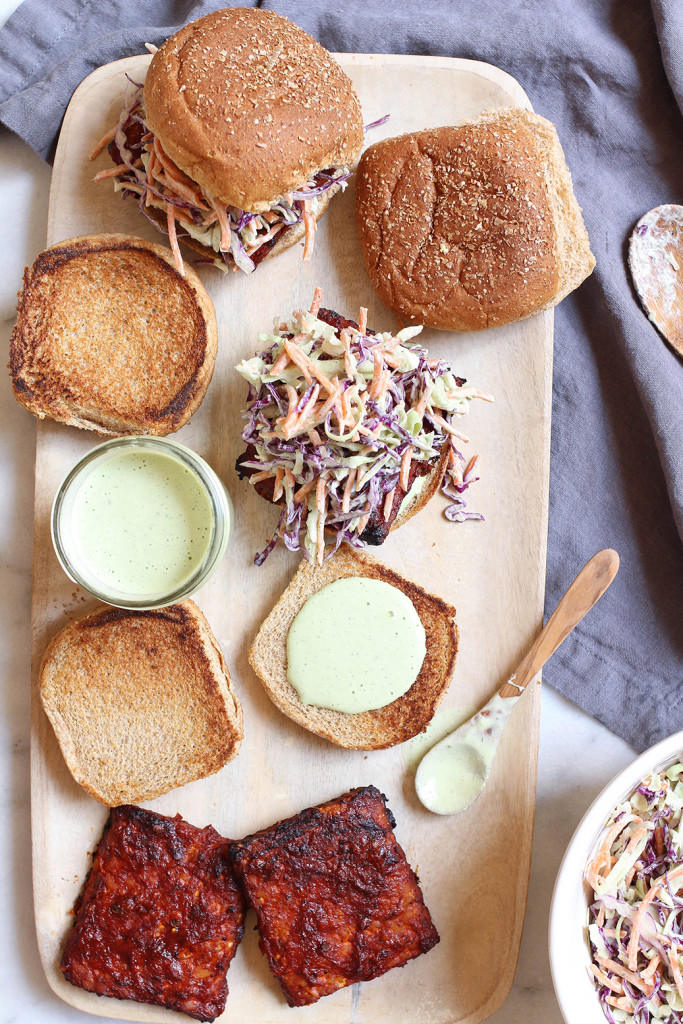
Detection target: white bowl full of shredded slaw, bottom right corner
<box><xmin>549</xmin><ymin>731</ymin><xmax>683</xmax><ymax>1024</ymax></box>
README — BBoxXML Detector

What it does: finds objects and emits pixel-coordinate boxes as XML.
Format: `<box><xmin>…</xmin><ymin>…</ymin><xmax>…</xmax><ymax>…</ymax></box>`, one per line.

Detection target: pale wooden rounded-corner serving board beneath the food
<box><xmin>32</xmin><ymin>54</ymin><xmax>553</xmax><ymax>1024</ymax></box>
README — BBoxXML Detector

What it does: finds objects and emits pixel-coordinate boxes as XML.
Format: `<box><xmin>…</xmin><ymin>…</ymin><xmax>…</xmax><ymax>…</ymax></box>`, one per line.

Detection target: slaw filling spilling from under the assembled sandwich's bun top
<box><xmin>89</xmin><ymin>79</ymin><xmax>351</xmax><ymax>274</ymax></box>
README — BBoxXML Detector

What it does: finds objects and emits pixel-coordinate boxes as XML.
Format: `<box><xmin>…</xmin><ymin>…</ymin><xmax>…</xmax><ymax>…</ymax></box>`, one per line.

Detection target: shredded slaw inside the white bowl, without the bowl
<box><xmin>585</xmin><ymin>763</ymin><xmax>683</xmax><ymax>1024</ymax></box>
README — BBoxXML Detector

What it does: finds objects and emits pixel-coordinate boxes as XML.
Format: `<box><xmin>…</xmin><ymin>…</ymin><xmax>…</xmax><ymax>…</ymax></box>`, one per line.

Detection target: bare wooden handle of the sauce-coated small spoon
<box><xmin>498</xmin><ymin>548</ymin><xmax>618</xmax><ymax>697</ymax></box>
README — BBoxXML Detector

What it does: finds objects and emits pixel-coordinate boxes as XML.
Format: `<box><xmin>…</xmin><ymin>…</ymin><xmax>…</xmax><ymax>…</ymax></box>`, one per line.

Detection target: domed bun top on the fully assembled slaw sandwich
<box><xmin>144</xmin><ymin>7</ymin><xmax>364</xmax><ymax>212</ymax></box>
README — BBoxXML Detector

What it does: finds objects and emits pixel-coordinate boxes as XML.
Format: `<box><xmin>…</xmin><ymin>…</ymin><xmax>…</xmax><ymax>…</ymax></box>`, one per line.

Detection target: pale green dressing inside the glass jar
<box><xmin>69</xmin><ymin>451</ymin><xmax>213</xmax><ymax>598</ymax></box>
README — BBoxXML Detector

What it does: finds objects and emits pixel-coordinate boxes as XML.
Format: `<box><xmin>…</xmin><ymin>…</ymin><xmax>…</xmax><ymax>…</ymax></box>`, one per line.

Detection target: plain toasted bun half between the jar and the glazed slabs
<box><xmin>39</xmin><ymin>601</ymin><xmax>243</xmax><ymax>807</ymax></box>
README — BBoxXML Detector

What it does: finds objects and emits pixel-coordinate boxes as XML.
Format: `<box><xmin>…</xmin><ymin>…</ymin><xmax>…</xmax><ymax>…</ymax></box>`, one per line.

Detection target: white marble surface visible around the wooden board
<box><xmin>0</xmin><ymin>14</ymin><xmax>634</xmax><ymax>1024</ymax></box>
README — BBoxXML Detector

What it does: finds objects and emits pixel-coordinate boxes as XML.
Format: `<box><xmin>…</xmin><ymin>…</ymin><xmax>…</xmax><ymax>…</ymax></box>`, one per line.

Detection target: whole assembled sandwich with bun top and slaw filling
<box><xmin>91</xmin><ymin>7</ymin><xmax>364</xmax><ymax>273</ymax></box>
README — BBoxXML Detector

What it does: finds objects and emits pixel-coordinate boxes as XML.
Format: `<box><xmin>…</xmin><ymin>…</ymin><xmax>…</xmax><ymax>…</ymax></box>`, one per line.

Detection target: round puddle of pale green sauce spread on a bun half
<box><xmin>287</xmin><ymin>577</ymin><xmax>426</xmax><ymax>715</ymax></box>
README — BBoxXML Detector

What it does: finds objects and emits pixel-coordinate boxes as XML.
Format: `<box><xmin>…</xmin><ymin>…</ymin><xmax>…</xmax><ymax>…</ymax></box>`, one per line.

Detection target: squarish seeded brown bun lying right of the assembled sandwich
<box><xmin>355</xmin><ymin>108</ymin><xmax>595</xmax><ymax>331</ymax></box>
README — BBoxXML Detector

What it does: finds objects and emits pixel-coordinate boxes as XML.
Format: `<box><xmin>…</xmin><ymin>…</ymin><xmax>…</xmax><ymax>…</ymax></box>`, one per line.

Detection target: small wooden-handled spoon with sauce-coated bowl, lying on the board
<box><xmin>415</xmin><ymin>548</ymin><xmax>618</xmax><ymax>814</ymax></box>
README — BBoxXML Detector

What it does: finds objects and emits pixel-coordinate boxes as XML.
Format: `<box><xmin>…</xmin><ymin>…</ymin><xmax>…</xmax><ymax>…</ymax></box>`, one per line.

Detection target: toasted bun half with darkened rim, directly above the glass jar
<box><xmin>9</xmin><ymin>234</ymin><xmax>218</xmax><ymax>436</ymax></box>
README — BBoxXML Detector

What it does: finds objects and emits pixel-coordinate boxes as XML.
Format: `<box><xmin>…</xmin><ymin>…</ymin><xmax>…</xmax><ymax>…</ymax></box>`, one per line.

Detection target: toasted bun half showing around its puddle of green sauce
<box><xmin>249</xmin><ymin>545</ymin><xmax>458</xmax><ymax>751</ymax></box>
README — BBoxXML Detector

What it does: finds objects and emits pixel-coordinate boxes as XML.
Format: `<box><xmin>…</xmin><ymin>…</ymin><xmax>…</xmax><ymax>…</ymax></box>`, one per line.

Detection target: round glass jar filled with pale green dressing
<box><xmin>52</xmin><ymin>436</ymin><xmax>233</xmax><ymax>608</ymax></box>
